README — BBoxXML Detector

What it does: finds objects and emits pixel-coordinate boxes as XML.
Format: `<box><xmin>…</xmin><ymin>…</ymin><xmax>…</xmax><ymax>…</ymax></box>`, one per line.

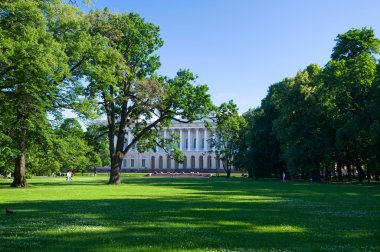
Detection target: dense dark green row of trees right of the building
<box><xmin>240</xmin><ymin>28</ymin><xmax>380</xmax><ymax>181</ymax></box>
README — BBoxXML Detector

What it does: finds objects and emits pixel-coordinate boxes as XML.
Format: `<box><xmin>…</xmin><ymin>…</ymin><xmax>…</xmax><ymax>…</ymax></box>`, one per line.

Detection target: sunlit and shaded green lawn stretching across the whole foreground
<box><xmin>0</xmin><ymin>176</ymin><xmax>380</xmax><ymax>251</ymax></box>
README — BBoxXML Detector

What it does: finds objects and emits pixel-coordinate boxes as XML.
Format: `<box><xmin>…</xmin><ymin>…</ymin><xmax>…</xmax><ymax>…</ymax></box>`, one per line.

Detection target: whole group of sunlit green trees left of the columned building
<box><xmin>0</xmin><ymin>0</ymin><xmax>213</xmax><ymax>186</ymax></box>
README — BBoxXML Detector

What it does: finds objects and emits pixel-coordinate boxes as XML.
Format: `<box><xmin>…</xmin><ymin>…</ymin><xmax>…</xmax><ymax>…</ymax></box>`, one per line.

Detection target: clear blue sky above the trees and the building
<box><xmin>79</xmin><ymin>0</ymin><xmax>380</xmax><ymax>113</ymax></box>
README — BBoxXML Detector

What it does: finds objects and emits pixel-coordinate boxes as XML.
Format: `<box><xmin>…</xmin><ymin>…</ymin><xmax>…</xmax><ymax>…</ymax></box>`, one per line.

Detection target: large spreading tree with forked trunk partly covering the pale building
<box><xmin>88</xmin><ymin>9</ymin><xmax>212</xmax><ymax>184</ymax></box>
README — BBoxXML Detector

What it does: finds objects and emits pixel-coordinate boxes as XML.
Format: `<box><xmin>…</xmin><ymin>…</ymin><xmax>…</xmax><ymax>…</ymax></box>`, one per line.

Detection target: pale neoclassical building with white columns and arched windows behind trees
<box><xmin>122</xmin><ymin>121</ymin><xmax>223</xmax><ymax>172</ymax></box>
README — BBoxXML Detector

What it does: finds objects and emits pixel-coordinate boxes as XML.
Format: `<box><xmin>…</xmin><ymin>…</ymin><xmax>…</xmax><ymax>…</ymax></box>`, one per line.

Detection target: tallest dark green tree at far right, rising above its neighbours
<box><xmin>324</xmin><ymin>28</ymin><xmax>380</xmax><ymax>180</ymax></box>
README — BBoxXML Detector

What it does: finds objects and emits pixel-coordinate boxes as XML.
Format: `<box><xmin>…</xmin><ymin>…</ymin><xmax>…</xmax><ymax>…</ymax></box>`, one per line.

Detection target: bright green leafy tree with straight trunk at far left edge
<box><xmin>0</xmin><ymin>0</ymin><xmax>90</xmax><ymax>186</ymax></box>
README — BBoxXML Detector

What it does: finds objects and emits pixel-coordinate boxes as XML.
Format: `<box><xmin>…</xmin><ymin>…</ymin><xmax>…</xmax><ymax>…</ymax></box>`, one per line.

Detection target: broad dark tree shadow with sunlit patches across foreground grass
<box><xmin>0</xmin><ymin>185</ymin><xmax>379</xmax><ymax>251</ymax></box>
